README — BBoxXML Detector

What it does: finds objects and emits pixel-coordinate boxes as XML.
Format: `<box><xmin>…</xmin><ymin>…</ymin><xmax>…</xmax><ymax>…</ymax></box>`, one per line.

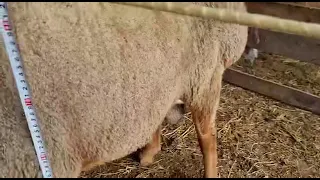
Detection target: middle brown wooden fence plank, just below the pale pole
<box><xmin>247</xmin><ymin>29</ymin><xmax>320</xmax><ymax>65</ymax></box>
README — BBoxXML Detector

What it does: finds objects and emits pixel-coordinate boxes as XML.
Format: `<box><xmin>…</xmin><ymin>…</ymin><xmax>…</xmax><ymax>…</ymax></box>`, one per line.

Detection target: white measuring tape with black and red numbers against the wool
<box><xmin>0</xmin><ymin>2</ymin><xmax>53</xmax><ymax>178</ymax></box>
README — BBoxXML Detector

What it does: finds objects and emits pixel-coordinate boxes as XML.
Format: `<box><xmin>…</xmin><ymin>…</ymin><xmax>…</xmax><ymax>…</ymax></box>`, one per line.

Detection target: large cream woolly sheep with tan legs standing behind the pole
<box><xmin>0</xmin><ymin>2</ymin><xmax>248</xmax><ymax>178</ymax></box>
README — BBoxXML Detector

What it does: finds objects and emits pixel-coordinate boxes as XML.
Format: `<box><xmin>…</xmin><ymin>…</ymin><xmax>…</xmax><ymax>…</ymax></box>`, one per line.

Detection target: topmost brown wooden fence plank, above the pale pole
<box><xmin>246</xmin><ymin>2</ymin><xmax>320</xmax><ymax>23</ymax></box>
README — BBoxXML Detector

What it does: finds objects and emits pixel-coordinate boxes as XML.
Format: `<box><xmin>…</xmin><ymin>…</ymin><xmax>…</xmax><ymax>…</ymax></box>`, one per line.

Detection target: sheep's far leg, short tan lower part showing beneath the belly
<box><xmin>140</xmin><ymin>126</ymin><xmax>161</xmax><ymax>166</ymax></box>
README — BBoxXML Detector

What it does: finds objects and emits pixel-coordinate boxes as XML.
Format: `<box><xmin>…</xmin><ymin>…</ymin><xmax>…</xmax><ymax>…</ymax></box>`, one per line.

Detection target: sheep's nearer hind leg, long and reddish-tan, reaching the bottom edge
<box><xmin>189</xmin><ymin>73</ymin><xmax>222</xmax><ymax>178</ymax></box>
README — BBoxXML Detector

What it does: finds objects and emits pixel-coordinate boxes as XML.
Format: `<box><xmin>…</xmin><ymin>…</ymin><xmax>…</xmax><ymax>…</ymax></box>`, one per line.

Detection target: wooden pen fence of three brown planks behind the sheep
<box><xmin>224</xmin><ymin>2</ymin><xmax>320</xmax><ymax>115</ymax></box>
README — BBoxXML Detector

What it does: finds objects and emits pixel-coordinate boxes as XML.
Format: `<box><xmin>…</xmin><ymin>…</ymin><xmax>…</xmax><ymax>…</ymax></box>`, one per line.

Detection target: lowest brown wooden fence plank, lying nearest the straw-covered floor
<box><xmin>223</xmin><ymin>69</ymin><xmax>320</xmax><ymax>115</ymax></box>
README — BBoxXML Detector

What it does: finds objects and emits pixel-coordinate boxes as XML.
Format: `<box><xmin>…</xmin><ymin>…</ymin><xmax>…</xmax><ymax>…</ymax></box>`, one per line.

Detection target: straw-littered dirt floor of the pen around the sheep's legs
<box><xmin>81</xmin><ymin>54</ymin><xmax>320</xmax><ymax>178</ymax></box>
